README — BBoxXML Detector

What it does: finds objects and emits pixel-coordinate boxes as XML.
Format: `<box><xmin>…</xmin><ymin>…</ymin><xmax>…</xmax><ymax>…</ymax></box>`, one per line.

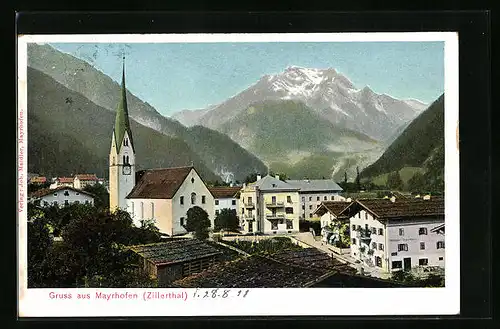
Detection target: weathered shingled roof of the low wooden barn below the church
<box><xmin>130</xmin><ymin>239</ymin><xmax>222</xmax><ymax>265</ymax></box>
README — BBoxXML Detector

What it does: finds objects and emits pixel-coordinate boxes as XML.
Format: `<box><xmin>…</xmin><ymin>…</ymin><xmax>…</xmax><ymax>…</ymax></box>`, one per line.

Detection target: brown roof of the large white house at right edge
<box><xmin>341</xmin><ymin>197</ymin><xmax>444</xmax><ymax>219</ymax></box>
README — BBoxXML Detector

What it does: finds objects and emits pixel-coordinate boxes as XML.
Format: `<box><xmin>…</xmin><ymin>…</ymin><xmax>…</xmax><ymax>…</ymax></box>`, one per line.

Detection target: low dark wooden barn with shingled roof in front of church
<box><xmin>129</xmin><ymin>239</ymin><xmax>222</xmax><ymax>288</ymax></box>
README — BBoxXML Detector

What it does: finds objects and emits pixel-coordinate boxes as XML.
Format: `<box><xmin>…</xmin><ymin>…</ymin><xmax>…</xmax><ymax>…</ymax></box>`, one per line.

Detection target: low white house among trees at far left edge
<box><xmin>28</xmin><ymin>186</ymin><xmax>94</xmax><ymax>207</ymax></box>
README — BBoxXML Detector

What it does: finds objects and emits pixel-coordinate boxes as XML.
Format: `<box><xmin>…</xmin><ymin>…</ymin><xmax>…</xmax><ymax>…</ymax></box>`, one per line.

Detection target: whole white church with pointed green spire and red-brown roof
<box><xmin>109</xmin><ymin>63</ymin><xmax>215</xmax><ymax>236</ymax></box>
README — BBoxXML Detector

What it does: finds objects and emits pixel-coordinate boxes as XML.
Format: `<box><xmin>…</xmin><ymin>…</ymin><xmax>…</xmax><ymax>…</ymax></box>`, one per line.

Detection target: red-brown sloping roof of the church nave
<box><xmin>127</xmin><ymin>167</ymin><xmax>194</xmax><ymax>199</ymax></box>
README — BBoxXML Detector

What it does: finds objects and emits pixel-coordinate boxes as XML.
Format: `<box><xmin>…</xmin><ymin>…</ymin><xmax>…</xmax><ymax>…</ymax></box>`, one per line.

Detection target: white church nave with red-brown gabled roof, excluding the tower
<box><xmin>126</xmin><ymin>167</ymin><xmax>215</xmax><ymax>236</ymax></box>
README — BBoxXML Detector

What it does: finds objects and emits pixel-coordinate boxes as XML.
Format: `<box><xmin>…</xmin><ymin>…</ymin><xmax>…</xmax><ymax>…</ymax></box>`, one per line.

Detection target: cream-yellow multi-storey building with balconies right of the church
<box><xmin>238</xmin><ymin>175</ymin><xmax>300</xmax><ymax>234</ymax></box>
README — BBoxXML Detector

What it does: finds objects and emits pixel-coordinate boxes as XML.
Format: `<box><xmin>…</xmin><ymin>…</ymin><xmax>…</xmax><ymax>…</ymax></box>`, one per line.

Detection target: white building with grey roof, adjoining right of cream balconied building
<box><xmin>286</xmin><ymin>179</ymin><xmax>345</xmax><ymax>220</ymax></box>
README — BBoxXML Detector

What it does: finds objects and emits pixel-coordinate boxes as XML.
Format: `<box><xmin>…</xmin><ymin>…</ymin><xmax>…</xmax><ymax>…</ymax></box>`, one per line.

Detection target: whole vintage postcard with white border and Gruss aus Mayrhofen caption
<box><xmin>17</xmin><ymin>32</ymin><xmax>460</xmax><ymax>317</ymax></box>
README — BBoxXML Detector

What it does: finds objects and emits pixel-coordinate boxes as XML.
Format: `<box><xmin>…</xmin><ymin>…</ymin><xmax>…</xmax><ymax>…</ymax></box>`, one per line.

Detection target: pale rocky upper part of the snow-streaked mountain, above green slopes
<box><xmin>179</xmin><ymin>66</ymin><xmax>427</xmax><ymax>140</ymax></box>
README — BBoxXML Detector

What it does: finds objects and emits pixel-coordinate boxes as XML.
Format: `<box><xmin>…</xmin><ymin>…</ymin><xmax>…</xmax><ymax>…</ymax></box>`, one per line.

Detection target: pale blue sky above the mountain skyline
<box><xmin>51</xmin><ymin>42</ymin><xmax>444</xmax><ymax>116</ymax></box>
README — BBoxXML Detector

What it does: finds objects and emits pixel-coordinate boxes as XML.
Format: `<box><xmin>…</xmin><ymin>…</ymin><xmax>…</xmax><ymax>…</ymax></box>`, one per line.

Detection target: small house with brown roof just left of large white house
<box><xmin>313</xmin><ymin>201</ymin><xmax>351</xmax><ymax>244</ymax></box>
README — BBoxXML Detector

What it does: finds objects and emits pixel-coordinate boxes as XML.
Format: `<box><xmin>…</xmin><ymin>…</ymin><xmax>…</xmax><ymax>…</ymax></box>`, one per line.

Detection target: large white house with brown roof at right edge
<box><xmin>340</xmin><ymin>197</ymin><xmax>445</xmax><ymax>273</ymax></box>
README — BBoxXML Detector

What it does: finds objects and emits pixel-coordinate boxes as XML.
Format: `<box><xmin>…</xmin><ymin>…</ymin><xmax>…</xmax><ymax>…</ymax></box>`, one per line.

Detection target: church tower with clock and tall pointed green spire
<box><xmin>109</xmin><ymin>57</ymin><xmax>135</xmax><ymax>211</ymax></box>
